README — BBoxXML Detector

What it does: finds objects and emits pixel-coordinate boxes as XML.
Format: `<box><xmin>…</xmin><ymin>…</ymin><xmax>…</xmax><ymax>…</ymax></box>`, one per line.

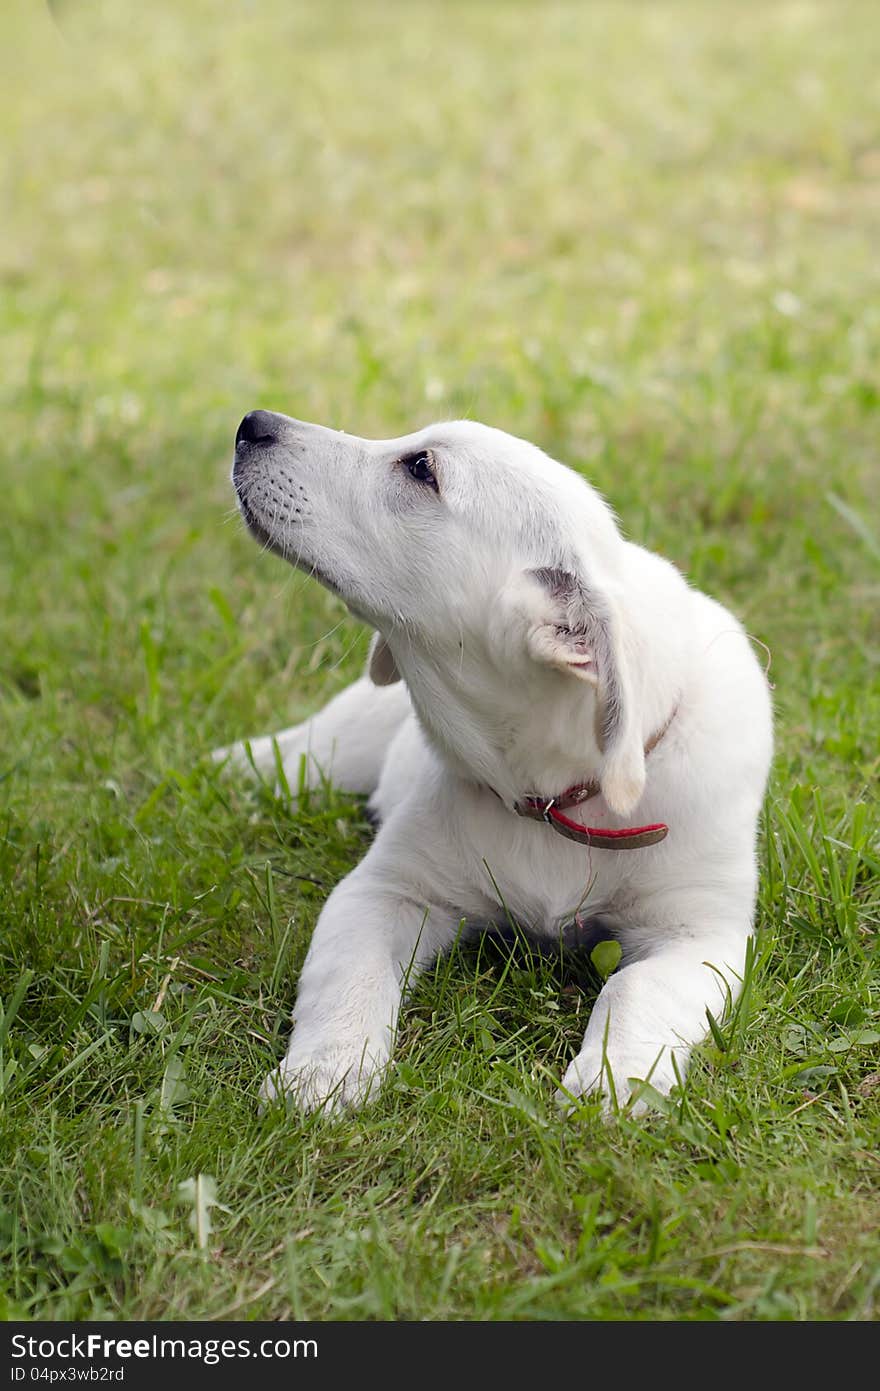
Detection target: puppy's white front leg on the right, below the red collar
<box><xmin>557</xmin><ymin>917</ymin><xmax>749</xmax><ymax>1111</ymax></box>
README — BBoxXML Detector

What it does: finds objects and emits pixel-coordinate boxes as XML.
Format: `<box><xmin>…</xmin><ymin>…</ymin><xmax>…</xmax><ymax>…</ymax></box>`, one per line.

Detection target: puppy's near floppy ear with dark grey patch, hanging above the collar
<box><xmin>527</xmin><ymin>569</ymin><xmax>645</xmax><ymax>817</ymax></box>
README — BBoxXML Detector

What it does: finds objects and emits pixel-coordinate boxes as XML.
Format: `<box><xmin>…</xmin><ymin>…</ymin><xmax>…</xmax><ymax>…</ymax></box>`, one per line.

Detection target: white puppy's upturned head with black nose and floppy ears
<box><xmin>232</xmin><ymin>410</ymin><xmax>645</xmax><ymax>814</ymax></box>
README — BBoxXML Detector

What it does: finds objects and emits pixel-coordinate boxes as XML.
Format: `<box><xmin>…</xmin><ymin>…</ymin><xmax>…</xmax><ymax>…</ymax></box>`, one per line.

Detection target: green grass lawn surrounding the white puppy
<box><xmin>0</xmin><ymin>0</ymin><xmax>880</xmax><ymax>1320</ymax></box>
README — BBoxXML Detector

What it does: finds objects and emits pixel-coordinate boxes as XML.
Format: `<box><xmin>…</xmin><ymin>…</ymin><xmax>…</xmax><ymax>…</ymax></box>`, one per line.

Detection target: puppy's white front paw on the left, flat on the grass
<box><xmin>260</xmin><ymin>1039</ymin><xmax>391</xmax><ymax>1113</ymax></box>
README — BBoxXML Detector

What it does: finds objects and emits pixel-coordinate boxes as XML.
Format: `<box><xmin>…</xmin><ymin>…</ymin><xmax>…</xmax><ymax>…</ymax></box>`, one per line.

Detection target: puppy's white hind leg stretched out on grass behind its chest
<box><xmin>213</xmin><ymin>676</ymin><xmax>412</xmax><ymax>793</ymax></box>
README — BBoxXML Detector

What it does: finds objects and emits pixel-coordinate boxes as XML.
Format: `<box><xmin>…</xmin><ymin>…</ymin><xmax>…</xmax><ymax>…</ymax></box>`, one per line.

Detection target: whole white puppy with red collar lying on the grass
<box><xmin>218</xmin><ymin>410</ymin><xmax>772</xmax><ymax>1109</ymax></box>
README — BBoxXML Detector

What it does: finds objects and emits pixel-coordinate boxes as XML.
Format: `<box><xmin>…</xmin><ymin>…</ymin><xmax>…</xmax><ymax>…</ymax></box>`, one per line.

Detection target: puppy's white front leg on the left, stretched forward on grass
<box><xmin>261</xmin><ymin>842</ymin><xmax>459</xmax><ymax>1111</ymax></box>
